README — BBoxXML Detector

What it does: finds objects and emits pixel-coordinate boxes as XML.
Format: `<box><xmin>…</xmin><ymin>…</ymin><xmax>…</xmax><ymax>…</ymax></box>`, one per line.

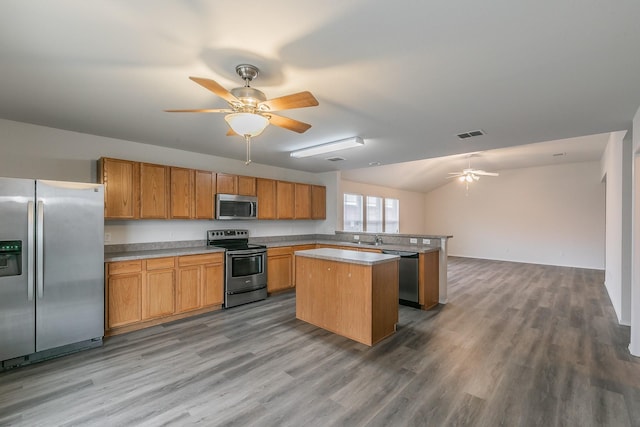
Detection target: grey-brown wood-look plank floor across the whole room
<box><xmin>0</xmin><ymin>258</ymin><xmax>640</xmax><ymax>427</ymax></box>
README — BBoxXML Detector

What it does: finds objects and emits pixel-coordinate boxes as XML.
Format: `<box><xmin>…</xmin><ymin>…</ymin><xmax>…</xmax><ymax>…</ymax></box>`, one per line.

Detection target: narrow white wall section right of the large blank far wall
<box><xmin>601</xmin><ymin>131</ymin><xmax>631</xmax><ymax>325</ymax></box>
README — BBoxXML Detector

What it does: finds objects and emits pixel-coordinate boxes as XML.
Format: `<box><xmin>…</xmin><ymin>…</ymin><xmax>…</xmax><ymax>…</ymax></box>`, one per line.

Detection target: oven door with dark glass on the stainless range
<box><xmin>225</xmin><ymin>249</ymin><xmax>267</xmax><ymax>294</ymax></box>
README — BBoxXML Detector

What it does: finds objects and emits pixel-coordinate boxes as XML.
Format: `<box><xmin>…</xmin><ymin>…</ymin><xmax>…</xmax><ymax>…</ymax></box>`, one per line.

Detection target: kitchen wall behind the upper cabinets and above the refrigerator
<box><xmin>0</xmin><ymin>119</ymin><xmax>337</xmax><ymax>244</ymax></box>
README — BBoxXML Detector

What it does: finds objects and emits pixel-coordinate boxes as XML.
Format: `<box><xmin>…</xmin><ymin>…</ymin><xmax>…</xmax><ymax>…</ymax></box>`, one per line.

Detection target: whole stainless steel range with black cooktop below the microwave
<box><xmin>207</xmin><ymin>230</ymin><xmax>267</xmax><ymax>308</ymax></box>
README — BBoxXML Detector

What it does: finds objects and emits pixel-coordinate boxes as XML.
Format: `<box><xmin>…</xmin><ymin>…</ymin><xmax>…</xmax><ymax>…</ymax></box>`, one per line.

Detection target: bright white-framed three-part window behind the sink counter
<box><xmin>342</xmin><ymin>194</ymin><xmax>400</xmax><ymax>233</ymax></box>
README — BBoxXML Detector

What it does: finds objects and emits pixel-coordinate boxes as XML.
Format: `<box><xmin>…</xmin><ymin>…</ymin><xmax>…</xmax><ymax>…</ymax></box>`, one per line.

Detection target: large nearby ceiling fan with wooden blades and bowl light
<box><xmin>165</xmin><ymin>64</ymin><xmax>318</xmax><ymax>164</ymax></box>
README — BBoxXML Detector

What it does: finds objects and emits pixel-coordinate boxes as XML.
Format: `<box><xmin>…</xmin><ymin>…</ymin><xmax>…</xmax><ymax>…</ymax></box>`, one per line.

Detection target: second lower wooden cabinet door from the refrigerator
<box><xmin>142</xmin><ymin>270</ymin><xmax>175</xmax><ymax>319</ymax></box>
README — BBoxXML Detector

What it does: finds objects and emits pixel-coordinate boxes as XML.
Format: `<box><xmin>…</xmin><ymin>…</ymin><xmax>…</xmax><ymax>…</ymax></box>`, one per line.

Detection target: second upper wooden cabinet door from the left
<box><xmin>140</xmin><ymin>163</ymin><xmax>169</xmax><ymax>219</ymax></box>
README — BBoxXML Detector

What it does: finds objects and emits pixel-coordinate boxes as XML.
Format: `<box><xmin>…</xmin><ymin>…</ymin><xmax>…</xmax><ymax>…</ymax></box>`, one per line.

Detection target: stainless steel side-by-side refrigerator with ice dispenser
<box><xmin>0</xmin><ymin>178</ymin><xmax>104</xmax><ymax>368</ymax></box>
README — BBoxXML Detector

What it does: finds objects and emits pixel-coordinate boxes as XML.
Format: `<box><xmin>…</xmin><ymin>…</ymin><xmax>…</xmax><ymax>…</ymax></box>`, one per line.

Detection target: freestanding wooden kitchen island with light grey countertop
<box><xmin>295</xmin><ymin>248</ymin><xmax>400</xmax><ymax>346</ymax></box>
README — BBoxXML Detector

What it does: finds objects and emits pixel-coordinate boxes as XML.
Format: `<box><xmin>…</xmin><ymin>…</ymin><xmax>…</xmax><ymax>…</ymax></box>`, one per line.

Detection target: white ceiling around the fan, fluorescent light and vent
<box><xmin>0</xmin><ymin>0</ymin><xmax>640</xmax><ymax>183</ymax></box>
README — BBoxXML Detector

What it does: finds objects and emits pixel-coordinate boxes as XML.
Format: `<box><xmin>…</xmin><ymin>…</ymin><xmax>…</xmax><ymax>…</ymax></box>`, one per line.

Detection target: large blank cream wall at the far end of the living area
<box><xmin>425</xmin><ymin>162</ymin><xmax>605</xmax><ymax>269</ymax></box>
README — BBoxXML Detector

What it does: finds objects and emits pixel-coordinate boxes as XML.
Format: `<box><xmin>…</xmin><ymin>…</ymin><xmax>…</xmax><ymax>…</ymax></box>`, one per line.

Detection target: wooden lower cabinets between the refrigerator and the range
<box><xmin>105</xmin><ymin>252</ymin><xmax>224</xmax><ymax>335</ymax></box>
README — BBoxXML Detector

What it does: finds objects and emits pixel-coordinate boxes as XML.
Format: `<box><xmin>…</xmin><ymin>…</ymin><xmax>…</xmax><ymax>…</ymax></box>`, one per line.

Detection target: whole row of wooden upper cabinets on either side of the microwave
<box><xmin>98</xmin><ymin>157</ymin><xmax>326</xmax><ymax>224</ymax></box>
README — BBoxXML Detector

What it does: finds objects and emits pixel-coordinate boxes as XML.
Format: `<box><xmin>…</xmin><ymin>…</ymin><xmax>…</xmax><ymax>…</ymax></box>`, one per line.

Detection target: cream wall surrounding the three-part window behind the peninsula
<box><xmin>337</xmin><ymin>180</ymin><xmax>431</xmax><ymax>234</ymax></box>
